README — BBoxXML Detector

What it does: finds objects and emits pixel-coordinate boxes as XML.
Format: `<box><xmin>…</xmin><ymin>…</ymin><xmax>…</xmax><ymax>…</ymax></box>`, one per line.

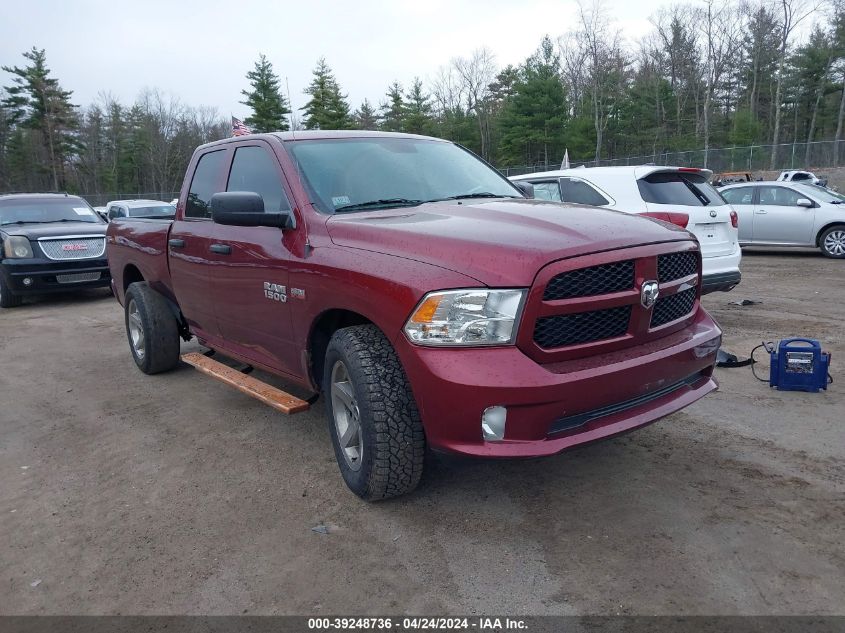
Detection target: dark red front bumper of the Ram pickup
<box><xmin>396</xmin><ymin>309</ymin><xmax>721</xmax><ymax>457</ymax></box>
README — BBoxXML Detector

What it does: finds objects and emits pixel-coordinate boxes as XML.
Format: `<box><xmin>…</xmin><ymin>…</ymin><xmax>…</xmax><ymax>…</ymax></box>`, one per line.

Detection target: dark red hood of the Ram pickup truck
<box><xmin>327</xmin><ymin>199</ymin><xmax>695</xmax><ymax>287</ymax></box>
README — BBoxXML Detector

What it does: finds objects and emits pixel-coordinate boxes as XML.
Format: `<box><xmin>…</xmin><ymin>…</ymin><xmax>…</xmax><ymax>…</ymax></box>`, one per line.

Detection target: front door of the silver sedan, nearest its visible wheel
<box><xmin>754</xmin><ymin>185</ymin><xmax>816</xmax><ymax>245</ymax></box>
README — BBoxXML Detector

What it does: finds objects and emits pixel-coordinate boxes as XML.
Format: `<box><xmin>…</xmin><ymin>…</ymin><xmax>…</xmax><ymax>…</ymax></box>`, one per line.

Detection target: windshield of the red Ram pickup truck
<box><xmin>287</xmin><ymin>137</ymin><xmax>522</xmax><ymax>213</ymax></box>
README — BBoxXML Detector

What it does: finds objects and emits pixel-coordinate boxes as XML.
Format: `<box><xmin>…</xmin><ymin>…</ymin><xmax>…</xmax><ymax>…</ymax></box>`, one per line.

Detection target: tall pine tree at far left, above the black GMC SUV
<box><xmin>2</xmin><ymin>46</ymin><xmax>81</xmax><ymax>191</ymax></box>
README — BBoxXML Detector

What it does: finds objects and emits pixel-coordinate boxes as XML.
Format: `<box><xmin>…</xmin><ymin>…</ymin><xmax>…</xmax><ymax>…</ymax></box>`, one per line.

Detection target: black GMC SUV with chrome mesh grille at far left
<box><xmin>0</xmin><ymin>193</ymin><xmax>111</xmax><ymax>308</ymax></box>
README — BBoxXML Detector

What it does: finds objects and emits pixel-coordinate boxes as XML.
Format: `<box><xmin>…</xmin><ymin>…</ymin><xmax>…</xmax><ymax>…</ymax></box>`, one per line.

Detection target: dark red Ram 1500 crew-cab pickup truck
<box><xmin>107</xmin><ymin>131</ymin><xmax>721</xmax><ymax>499</ymax></box>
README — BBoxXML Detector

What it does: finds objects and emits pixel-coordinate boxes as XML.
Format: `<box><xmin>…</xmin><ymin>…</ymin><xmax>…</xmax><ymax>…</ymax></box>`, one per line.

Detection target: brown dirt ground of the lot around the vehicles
<box><xmin>0</xmin><ymin>251</ymin><xmax>845</xmax><ymax>615</ymax></box>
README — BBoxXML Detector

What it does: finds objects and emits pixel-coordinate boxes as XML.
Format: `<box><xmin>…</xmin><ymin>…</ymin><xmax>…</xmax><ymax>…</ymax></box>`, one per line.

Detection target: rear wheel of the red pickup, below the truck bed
<box><xmin>123</xmin><ymin>281</ymin><xmax>179</xmax><ymax>374</ymax></box>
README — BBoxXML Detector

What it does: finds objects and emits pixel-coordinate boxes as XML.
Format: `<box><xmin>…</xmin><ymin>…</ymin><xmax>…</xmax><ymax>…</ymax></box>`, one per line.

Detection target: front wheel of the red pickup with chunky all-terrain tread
<box><xmin>323</xmin><ymin>325</ymin><xmax>425</xmax><ymax>501</ymax></box>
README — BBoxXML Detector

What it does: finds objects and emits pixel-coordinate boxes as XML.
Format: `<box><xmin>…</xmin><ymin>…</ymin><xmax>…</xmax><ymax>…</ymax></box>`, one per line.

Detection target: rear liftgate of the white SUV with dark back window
<box><xmin>637</xmin><ymin>169</ymin><xmax>736</xmax><ymax>259</ymax></box>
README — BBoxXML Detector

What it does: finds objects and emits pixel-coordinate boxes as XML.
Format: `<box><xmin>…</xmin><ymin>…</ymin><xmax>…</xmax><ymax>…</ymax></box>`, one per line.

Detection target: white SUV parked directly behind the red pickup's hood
<box><xmin>511</xmin><ymin>165</ymin><xmax>742</xmax><ymax>293</ymax></box>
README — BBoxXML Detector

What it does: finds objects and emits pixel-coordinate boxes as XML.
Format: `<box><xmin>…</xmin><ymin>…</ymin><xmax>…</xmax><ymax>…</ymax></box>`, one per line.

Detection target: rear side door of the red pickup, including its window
<box><xmin>168</xmin><ymin>148</ymin><xmax>228</xmax><ymax>338</ymax></box>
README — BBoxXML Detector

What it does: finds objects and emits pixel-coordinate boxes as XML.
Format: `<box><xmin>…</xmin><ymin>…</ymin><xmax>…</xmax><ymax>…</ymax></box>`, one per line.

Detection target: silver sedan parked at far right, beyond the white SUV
<box><xmin>720</xmin><ymin>182</ymin><xmax>845</xmax><ymax>259</ymax></box>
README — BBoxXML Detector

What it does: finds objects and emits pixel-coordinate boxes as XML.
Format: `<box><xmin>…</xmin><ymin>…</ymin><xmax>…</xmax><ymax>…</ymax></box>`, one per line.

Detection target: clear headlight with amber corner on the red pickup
<box><xmin>405</xmin><ymin>288</ymin><xmax>526</xmax><ymax>346</ymax></box>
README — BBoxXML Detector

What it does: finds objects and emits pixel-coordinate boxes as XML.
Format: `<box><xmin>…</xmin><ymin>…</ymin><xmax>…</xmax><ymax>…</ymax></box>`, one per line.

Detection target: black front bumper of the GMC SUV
<box><xmin>0</xmin><ymin>257</ymin><xmax>111</xmax><ymax>295</ymax></box>
